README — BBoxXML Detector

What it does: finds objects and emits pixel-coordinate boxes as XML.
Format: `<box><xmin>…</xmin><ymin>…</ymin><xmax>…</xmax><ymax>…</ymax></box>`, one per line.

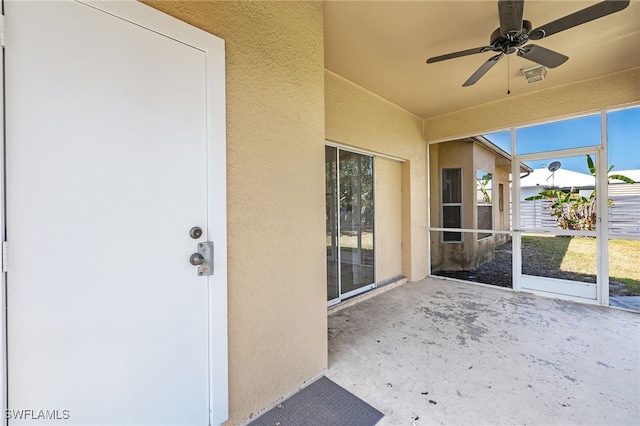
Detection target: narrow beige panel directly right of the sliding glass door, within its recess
<box><xmin>374</xmin><ymin>157</ymin><xmax>402</xmax><ymax>282</ymax></box>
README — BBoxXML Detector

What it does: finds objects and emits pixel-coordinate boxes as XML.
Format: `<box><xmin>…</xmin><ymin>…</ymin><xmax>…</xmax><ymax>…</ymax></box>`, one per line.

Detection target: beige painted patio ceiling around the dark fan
<box><xmin>324</xmin><ymin>0</ymin><xmax>640</xmax><ymax>118</ymax></box>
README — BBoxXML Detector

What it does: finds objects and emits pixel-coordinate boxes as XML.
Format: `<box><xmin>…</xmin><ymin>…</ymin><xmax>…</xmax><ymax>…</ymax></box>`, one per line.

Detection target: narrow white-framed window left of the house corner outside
<box><xmin>442</xmin><ymin>169</ymin><xmax>462</xmax><ymax>243</ymax></box>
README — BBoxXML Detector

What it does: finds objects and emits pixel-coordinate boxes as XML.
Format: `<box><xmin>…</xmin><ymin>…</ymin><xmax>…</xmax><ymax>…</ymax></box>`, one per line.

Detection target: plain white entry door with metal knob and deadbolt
<box><xmin>5</xmin><ymin>1</ymin><xmax>226</xmax><ymax>425</ymax></box>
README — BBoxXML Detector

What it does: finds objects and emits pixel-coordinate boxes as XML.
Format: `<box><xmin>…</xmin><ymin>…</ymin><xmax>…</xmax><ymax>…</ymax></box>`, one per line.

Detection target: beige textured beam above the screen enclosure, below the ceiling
<box><xmin>425</xmin><ymin>68</ymin><xmax>640</xmax><ymax>141</ymax></box>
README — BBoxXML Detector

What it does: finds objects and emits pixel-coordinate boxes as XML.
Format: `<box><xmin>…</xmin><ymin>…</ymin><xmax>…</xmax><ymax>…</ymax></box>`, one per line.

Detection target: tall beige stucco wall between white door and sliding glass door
<box><xmin>147</xmin><ymin>1</ymin><xmax>327</xmax><ymax>424</ymax></box>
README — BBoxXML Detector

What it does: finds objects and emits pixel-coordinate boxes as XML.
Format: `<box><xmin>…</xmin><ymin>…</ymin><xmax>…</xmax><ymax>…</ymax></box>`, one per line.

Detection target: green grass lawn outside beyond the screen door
<box><xmin>522</xmin><ymin>235</ymin><xmax>640</xmax><ymax>295</ymax></box>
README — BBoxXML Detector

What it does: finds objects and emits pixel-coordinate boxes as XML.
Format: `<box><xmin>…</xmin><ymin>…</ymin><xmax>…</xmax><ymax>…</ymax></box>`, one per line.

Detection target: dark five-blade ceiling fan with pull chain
<box><xmin>427</xmin><ymin>0</ymin><xmax>630</xmax><ymax>87</ymax></box>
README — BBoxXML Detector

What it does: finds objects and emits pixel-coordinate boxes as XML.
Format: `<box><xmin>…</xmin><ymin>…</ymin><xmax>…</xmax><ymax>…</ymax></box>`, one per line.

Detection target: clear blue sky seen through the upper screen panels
<box><xmin>484</xmin><ymin>107</ymin><xmax>640</xmax><ymax>174</ymax></box>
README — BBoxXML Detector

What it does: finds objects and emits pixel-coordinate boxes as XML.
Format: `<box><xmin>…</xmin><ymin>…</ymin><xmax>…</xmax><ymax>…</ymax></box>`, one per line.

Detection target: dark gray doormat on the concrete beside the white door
<box><xmin>249</xmin><ymin>376</ymin><xmax>384</xmax><ymax>426</ymax></box>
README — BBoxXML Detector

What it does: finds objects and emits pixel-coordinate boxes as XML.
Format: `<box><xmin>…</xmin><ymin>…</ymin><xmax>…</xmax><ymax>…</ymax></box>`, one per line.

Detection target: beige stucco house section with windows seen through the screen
<box><xmin>429</xmin><ymin>137</ymin><xmax>531</xmax><ymax>272</ymax></box>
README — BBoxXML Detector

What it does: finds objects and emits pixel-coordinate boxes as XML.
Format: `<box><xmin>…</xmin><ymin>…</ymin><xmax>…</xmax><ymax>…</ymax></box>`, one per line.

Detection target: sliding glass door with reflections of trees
<box><xmin>325</xmin><ymin>146</ymin><xmax>375</xmax><ymax>301</ymax></box>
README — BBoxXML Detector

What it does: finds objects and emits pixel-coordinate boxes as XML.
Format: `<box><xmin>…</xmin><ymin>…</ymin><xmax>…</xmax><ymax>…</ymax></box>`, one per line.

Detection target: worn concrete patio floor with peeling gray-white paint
<box><xmin>326</xmin><ymin>278</ymin><xmax>640</xmax><ymax>426</ymax></box>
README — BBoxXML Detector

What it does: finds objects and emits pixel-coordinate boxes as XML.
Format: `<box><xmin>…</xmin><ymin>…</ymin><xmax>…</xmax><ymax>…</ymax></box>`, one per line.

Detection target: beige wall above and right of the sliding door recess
<box><xmin>325</xmin><ymin>71</ymin><xmax>428</xmax><ymax>281</ymax></box>
